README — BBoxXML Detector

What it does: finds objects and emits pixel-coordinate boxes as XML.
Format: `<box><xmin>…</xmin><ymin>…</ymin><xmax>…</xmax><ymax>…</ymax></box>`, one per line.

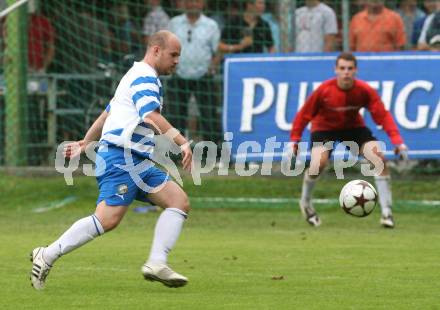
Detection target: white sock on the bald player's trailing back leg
<box><xmin>43</xmin><ymin>215</ymin><xmax>104</xmax><ymax>265</ymax></box>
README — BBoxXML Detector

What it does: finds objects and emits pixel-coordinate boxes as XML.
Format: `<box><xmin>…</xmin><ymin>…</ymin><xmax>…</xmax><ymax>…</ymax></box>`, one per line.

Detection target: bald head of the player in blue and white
<box><xmin>145</xmin><ymin>30</ymin><xmax>181</xmax><ymax>75</ymax></box>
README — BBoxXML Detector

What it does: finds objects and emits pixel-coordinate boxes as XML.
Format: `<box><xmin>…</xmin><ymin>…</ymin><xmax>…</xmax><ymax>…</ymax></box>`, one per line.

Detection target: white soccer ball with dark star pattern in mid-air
<box><xmin>339</xmin><ymin>180</ymin><xmax>377</xmax><ymax>217</ymax></box>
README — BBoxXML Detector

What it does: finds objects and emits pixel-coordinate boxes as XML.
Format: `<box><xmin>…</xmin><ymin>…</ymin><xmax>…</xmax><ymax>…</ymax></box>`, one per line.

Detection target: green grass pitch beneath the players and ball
<box><xmin>0</xmin><ymin>175</ymin><xmax>440</xmax><ymax>309</ymax></box>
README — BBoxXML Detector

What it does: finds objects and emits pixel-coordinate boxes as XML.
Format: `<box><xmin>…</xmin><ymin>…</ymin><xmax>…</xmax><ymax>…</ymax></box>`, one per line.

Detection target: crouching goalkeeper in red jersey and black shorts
<box><xmin>290</xmin><ymin>53</ymin><xmax>408</xmax><ymax>228</ymax></box>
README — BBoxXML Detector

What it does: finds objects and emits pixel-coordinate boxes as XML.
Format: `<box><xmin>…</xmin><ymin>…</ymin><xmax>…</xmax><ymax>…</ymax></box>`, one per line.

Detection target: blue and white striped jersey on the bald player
<box><xmin>100</xmin><ymin>62</ymin><xmax>163</xmax><ymax>158</ymax></box>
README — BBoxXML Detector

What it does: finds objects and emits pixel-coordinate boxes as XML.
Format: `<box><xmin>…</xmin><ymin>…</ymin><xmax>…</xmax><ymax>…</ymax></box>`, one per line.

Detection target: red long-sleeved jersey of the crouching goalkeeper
<box><xmin>290</xmin><ymin>78</ymin><xmax>403</xmax><ymax>145</ymax></box>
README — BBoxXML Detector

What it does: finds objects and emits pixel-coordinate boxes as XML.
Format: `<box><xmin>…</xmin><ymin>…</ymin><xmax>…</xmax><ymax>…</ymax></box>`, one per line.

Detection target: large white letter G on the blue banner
<box><xmin>394</xmin><ymin>80</ymin><xmax>433</xmax><ymax>129</ymax></box>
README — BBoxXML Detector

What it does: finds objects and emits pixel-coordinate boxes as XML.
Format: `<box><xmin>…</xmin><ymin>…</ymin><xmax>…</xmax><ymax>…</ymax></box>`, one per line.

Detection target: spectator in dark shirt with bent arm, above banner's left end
<box><xmin>219</xmin><ymin>0</ymin><xmax>275</xmax><ymax>53</ymax></box>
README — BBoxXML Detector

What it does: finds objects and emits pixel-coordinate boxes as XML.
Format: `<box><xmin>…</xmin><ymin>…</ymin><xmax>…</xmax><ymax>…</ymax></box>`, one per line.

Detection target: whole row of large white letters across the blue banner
<box><xmin>240</xmin><ymin>78</ymin><xmax>440</xmax><ymax>132</ymax></box>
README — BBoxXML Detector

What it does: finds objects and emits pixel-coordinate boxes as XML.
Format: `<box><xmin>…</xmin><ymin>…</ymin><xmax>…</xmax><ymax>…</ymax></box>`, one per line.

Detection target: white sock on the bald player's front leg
<box><xmin>148</xmin><ymin>208</ymin><xmax>187</xmax><ymax>264</ymax></box>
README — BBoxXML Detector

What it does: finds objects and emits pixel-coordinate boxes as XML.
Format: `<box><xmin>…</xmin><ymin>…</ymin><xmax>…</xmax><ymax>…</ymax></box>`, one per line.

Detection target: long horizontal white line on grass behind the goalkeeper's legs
<box><xmin>190</xmin><ymin>197</ymin><xmax>440</xmax><ymax>207</ymax></box>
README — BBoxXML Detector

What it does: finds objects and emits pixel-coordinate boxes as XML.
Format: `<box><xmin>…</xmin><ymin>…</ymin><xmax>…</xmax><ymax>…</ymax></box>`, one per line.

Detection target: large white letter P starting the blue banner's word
<box><xmin>240</xmin><ymin>78</ymin><xmax>274</xmax><ymax>132</ymax></box>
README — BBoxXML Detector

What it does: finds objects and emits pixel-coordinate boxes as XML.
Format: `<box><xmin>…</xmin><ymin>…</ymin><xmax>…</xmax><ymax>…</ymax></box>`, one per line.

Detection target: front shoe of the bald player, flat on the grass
<box><xmin>141</xmin><ymin>262</ymin><xmax>188</xmax><ymax>287</ymax></box>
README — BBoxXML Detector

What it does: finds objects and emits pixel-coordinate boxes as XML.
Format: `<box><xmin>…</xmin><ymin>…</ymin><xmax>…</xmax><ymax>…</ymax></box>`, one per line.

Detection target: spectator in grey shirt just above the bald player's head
<box><xmin>143</xmin><ymin>0</ymin><xmax>170</xmax><ymax>46</ymax></box>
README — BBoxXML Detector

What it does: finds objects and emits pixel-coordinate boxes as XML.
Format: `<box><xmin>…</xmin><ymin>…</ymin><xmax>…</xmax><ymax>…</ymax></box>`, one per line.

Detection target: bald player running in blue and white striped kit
<box><xmin>31</xmin><ymin>31</ymin><xmax>192</xmax><ymax>290</ymax></box>
